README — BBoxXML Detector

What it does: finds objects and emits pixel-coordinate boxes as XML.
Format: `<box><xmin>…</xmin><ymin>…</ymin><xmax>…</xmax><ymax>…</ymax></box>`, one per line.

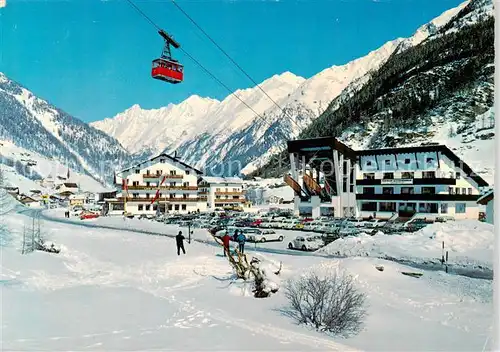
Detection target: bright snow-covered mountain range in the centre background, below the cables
<box><xmin>92</xmin><ymin>1</ymin><xmax>469</xmax><ymax>173</ymax></box>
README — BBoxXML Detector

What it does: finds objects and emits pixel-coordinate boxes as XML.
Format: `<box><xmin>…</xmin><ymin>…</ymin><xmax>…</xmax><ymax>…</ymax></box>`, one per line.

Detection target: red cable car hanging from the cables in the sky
<box><xmin>151</xmin><ymin>29</ymin><xmax>184</xmax><ymax>84</ymax></box>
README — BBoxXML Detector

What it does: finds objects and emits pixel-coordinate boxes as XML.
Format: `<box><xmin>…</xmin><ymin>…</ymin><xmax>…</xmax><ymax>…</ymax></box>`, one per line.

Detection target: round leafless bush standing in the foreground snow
<box><xmin>284</xmin><ymin>272</ymin><xmax>366</xmax><ymax>334</ymax></box>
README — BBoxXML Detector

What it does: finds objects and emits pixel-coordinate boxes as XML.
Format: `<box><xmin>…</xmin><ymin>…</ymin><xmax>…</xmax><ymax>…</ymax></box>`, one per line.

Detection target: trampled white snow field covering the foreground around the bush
<box><xmin>0</xmin><ymin>195</ymin><xmax>493</xmax><ymax>351</ymax></box>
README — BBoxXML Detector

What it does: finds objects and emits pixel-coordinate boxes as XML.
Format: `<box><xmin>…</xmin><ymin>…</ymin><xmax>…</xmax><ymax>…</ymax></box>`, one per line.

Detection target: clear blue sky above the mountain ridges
<box><xmin>0</xmin><ymin>0</ymin><xmax>462</xmax><ymax>122</ymax></box>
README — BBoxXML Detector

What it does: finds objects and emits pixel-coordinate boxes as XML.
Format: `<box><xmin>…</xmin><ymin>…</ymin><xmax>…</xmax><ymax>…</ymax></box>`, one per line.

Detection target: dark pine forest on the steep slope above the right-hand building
<box><xmin>252</xmin><ymin>14</ymin><xmax>494</xmax><ymax>177</ymax></box>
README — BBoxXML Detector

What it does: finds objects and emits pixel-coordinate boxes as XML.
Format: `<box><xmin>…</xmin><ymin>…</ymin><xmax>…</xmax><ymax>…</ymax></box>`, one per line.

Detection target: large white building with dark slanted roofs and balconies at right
<box><xmin>285</xmin><ymin>137</ymin><xmax>488</xmax><ymax>219</ymax></box>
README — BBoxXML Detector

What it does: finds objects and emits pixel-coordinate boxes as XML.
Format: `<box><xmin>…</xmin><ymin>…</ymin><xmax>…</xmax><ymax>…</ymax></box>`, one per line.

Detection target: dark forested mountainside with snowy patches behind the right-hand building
<box><xmin>255</xmin><ymin>0</ymin><xmax>495</xmax><ymax>183</ymax></box>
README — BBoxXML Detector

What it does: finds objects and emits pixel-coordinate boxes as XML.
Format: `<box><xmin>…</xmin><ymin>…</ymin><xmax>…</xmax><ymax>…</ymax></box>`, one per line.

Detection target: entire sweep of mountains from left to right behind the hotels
<box><xmin>0</xmin><ymin>0</ymin><xmax>494</xmax><ymax>187</ymax></box>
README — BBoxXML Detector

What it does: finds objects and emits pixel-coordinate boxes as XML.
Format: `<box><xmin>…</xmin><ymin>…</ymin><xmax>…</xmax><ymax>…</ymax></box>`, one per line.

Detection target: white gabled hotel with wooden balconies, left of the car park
<box><xmin>107</xmin><ymin>154</ymin><xmax>206</xmax><ymax>215</ymax></box>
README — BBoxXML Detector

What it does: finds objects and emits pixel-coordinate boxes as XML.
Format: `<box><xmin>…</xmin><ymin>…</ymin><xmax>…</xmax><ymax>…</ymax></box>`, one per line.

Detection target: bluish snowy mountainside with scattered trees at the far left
<box><xmin>0</xmin><ymin>72</ymin><xmax>143</xmax><ymax>181</ymax></box>
